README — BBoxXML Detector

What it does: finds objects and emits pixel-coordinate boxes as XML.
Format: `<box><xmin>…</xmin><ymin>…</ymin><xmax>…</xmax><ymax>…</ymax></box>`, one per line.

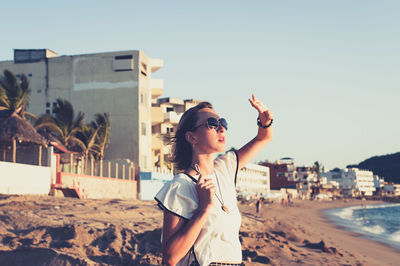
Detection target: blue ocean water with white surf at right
<box><xmin>326</xmin><ymin>203</ymin><xmax>400</xmax><ymax>250</ymax></box>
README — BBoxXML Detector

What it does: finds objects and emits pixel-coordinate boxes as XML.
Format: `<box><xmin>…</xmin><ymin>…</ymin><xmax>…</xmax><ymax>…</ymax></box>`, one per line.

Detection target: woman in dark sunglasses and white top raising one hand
<box><xmin>155</xmin><ymin>95</ymin><xmax>273</xmax><ymax>265</ymax></box>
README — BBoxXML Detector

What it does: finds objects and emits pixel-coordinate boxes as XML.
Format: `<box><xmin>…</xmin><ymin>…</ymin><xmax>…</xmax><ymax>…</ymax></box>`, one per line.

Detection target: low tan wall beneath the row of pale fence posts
<box><xmin>60</xmin><ymin>173</ymin><xmax>137</xmax><ymax>199</ymax></box>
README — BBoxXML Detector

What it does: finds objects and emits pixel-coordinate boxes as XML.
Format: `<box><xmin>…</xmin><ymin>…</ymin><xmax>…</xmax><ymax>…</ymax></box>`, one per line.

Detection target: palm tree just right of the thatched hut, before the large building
<box><xmin>35</xmin><ymin>98</ymin><xmax>86</xmax><ymax>151</ymax></box>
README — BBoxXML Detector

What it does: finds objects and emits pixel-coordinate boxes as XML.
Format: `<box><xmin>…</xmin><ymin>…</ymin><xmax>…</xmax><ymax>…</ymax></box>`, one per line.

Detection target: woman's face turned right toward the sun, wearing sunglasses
<box><xmin>193</xmin><ymin>108</ymin><xmax>226</xmax><ymax>154</ymax></box>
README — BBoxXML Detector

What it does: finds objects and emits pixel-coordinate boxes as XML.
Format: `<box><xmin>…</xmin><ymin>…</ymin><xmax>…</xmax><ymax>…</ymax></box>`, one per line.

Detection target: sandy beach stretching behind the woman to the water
<box><xmin>0</xmin><ymin>195</ymin><xmax>400</xmax><ymax>265</ymax></box>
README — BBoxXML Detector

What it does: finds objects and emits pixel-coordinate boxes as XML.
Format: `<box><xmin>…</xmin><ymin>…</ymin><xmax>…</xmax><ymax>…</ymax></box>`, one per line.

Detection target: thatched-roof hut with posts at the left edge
<box><xmin>0</xmin><ymin>110</ymin><xmax>47</xmax><ymax>165</ymax></box>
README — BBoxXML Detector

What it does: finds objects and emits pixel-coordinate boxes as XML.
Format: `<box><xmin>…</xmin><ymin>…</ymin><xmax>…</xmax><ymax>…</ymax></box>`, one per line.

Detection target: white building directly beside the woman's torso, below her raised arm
<box><xmin>236</xmin><ymin>163</ymin><xmax>270</xmax><ymax>195</ymax></box>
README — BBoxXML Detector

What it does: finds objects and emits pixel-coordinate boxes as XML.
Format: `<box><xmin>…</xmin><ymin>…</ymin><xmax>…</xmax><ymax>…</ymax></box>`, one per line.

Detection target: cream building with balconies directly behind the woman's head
<box><xmin>151</xmin><ymin>97</ymin><xmax>205</xmax><ymax>170</ymax></box>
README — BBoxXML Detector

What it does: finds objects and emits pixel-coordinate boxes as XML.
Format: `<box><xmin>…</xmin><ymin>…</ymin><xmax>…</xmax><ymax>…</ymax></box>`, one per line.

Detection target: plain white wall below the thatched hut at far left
<box><xmin>0</xmin><ymin>161</ymin><xmax>51</xmax><ymax>195</ymax></box>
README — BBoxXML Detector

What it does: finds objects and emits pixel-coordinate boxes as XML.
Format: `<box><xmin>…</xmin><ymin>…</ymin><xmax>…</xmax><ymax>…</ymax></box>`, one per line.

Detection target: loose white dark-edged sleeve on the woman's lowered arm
<box><xmin>154</xmin><ymin>177</ymin><xmax>199</xmax><ymax>220</ymax></box>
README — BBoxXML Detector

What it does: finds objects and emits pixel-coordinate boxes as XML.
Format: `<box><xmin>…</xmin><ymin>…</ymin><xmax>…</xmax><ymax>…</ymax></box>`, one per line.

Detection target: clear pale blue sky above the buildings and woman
<box><xmin>0</xmin><ymin>0</ymin><xmax>400</xmax><ymax>169</ymax></box>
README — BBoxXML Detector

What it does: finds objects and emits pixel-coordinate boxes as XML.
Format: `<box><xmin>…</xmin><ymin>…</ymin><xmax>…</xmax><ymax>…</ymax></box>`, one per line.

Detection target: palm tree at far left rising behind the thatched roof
<box><xmin>0</xmin><ymin>69</ymin><xmax>30</xmax><ymax>118</ymax></box>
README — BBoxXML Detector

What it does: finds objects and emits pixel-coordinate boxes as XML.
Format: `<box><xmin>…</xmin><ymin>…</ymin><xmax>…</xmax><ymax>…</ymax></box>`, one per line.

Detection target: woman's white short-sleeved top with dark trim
<box><xmin>155</xmin><ymin>152</ymin><xmax>242</xmax><ymax>265</ymax></box>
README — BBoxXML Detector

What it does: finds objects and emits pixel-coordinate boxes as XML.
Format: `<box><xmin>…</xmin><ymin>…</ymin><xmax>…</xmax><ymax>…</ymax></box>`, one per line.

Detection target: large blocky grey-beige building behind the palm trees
<box><xmin>0</xmin><ymin>49</ymin><xmax>163</xmax><ymax>170</ymax></box>
